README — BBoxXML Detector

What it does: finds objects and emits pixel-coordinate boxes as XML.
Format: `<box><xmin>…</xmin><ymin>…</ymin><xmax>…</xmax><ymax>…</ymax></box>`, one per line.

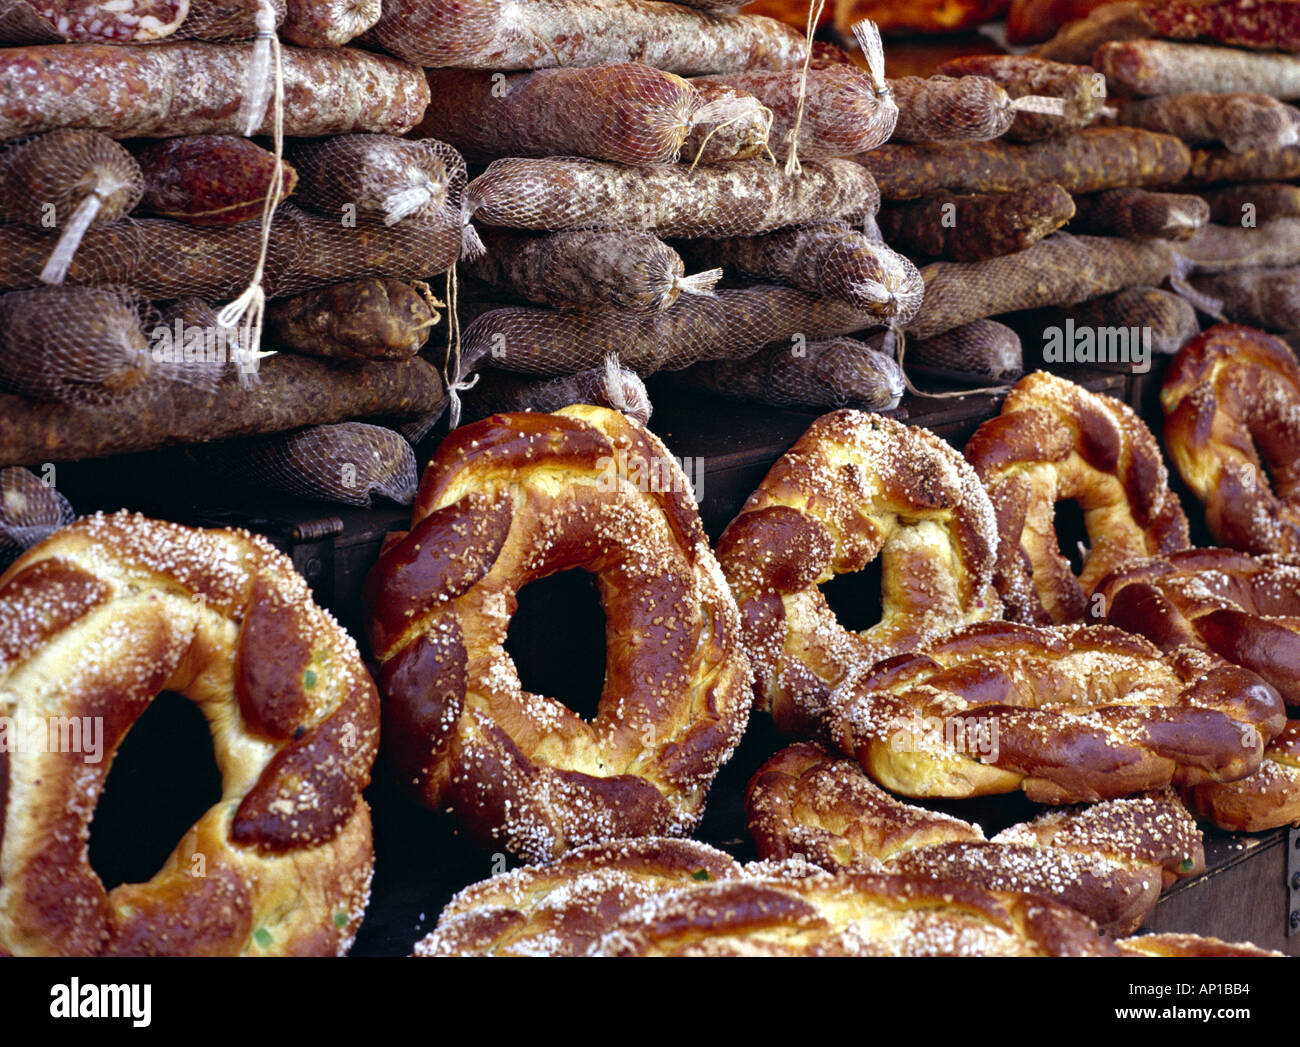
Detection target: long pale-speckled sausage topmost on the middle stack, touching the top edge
<box><xmin>365</xmin><ymin>0</ymin><xmax>807</xmax><ymax>77</ymax></box>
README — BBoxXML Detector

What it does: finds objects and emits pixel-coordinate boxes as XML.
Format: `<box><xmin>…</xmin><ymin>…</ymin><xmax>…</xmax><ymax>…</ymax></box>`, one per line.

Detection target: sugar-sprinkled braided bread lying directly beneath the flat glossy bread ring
<box><xmin>746</xmin><ymin>743</ymin><xmax>1205</xmax><ymax>934</ymax></box>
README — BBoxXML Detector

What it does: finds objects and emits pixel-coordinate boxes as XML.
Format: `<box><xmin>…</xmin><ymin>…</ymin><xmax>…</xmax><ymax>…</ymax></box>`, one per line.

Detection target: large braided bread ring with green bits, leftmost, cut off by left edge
<box><xmin>0</xmin><ymin>514</ymin><xmax>380</xmax><ymax>956</ymax></box>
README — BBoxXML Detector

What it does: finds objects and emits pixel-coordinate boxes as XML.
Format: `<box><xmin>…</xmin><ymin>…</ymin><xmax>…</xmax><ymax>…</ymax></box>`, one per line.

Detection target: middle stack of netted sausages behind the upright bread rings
<box><xmin>353</xmin><ymin>0</ymin><xmax>920</xmax><ymax>419</ymax></box>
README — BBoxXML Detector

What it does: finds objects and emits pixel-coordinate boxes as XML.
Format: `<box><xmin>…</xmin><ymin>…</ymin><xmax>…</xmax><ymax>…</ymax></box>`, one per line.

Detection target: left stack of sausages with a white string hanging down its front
<box><xmin>0</xmin><ymin>0</ymin><xmax>465</xmax><ymax>466</ymax></box>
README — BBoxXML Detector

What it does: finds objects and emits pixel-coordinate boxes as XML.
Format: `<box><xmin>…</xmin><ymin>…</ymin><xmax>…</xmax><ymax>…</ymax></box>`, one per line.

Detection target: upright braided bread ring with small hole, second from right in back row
<box><xmin>966</xmin><ymin>371</ymin><xmax>1188</xmax><ymax>626</ymax></box>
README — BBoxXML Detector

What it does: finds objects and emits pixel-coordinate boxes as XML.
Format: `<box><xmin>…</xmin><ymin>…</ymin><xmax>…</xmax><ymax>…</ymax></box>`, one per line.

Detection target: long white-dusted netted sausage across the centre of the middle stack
<box><xmin>463</xmin><ymin>153</ymin><xmax>880</xmax><ymax>237</ymax></box>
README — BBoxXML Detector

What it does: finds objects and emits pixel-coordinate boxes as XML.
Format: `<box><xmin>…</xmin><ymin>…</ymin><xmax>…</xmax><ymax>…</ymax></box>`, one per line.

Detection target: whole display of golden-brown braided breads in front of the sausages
<box><xmin>0</xmin><ymin>308</ymin><xmax>1300</xmax><ymax>955</ymax></box>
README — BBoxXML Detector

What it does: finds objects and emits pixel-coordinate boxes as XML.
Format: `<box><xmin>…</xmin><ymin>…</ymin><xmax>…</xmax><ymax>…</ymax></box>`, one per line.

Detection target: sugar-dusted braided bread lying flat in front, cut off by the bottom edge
<box><xmin>415</xmin><ymin>838</ymin><xmax>1118</xmax><ymax>956</ymax></box>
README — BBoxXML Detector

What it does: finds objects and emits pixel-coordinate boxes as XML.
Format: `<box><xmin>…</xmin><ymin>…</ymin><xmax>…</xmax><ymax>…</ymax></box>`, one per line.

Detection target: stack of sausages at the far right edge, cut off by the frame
<box><xmin>1011</xmin><ymin>0</ymin><xmax>1300</xmax><ymax>343</ymax></box>
